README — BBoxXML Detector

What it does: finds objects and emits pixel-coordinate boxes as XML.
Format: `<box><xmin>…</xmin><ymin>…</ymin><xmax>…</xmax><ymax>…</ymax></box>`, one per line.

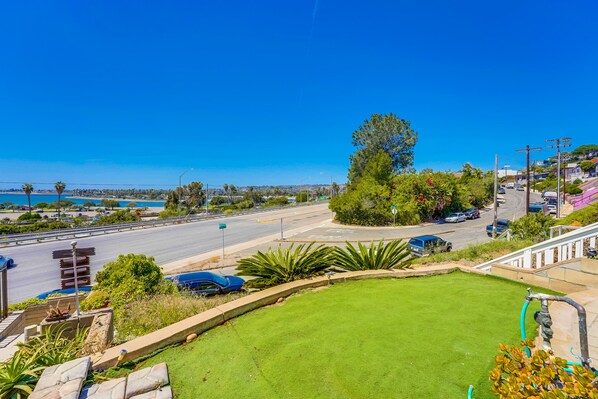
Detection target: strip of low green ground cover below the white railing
<box><xmin>413</xmin><ymin>240</ymin><xmax>534</xmax><ymax>266</ymax></box>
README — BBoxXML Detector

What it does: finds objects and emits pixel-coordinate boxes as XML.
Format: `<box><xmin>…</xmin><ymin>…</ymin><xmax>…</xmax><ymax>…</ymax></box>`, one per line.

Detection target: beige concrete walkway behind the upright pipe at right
<box><xmin>540</xmin><ymin>290</ymin><xmax>598</xmax><ymax>367</ymax></box>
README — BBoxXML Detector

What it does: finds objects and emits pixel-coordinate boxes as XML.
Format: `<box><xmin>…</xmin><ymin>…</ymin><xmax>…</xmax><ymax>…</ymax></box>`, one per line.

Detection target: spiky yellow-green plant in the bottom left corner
<box><xmin>0</xmin><ymin>351</ymin><xmax>44</xmax><ymax>399</ymax></box>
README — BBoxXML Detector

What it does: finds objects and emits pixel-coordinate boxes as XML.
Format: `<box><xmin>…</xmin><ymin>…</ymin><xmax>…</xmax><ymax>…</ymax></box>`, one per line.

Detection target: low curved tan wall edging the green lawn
<box><xmin>92</xmin><ymin>264</ymin><xmax>488</xmax><ymax>370</ymax></box>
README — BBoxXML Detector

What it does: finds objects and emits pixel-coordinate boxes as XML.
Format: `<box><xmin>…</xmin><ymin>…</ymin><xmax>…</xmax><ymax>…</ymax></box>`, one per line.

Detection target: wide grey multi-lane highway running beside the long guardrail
<box><xmin>0</xmin><ymin>203</ymin><xmax>331</xmax><ymax>303</ymax></box>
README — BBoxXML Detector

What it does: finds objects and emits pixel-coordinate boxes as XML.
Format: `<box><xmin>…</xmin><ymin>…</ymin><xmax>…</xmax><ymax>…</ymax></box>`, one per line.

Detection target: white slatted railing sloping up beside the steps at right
<box><xmin>474</xmin><ymin>223</ymin><xmax>598</xmax><ymax>271</ymax></box>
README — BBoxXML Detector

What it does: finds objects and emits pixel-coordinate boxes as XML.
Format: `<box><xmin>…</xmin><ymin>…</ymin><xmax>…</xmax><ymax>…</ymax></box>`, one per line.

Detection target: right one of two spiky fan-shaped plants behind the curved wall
<box><xmin>333</xmin><ymin>240</ymin><xmax>411</xmax><ymax>271</ymax></box>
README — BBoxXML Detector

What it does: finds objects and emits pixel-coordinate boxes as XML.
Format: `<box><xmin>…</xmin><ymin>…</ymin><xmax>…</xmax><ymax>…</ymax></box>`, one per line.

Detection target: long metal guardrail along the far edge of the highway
<box><xmin>0</xmin><ymin>201</ymin><xmax>324</xmax><ymax>245</ymax></box>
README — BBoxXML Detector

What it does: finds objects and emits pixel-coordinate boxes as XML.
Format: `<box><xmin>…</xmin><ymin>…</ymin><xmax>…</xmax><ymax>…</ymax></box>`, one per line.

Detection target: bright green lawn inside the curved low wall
<box><xmin>139</xmin><ymin>272</ymin><xmax>556</xmax><ymax>399</ymax></box>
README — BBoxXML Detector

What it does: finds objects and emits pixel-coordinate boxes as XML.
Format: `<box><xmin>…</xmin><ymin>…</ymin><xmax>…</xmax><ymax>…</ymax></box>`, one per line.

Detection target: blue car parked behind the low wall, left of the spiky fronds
<box><xmin>166</xmin><ymin>272</ymin><xmax>245</xmax><ymax>295</ymax></box>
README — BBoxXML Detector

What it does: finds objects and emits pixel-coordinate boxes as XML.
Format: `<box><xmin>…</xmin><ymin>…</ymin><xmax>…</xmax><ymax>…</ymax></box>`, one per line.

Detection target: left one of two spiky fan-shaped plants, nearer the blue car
<box><xmin>237</xmin><ymin>242</ymin><xmax>332</xmax><ymax>288</ymax></box>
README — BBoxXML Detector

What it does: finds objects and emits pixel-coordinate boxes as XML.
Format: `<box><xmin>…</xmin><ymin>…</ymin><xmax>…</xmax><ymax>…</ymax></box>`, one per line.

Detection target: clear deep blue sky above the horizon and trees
<box><xmin>0</xmin><ymin>0</ymin><xmax>598</xmax><ymax>187</ymax></box>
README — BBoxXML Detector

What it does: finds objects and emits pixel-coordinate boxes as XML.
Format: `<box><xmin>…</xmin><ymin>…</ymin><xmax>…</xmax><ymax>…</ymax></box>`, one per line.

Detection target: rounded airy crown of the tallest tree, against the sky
<box><xmin>349</xmin><ymin>113</ymin><xmax>417</xmax><ymax>183</ymax></box>
